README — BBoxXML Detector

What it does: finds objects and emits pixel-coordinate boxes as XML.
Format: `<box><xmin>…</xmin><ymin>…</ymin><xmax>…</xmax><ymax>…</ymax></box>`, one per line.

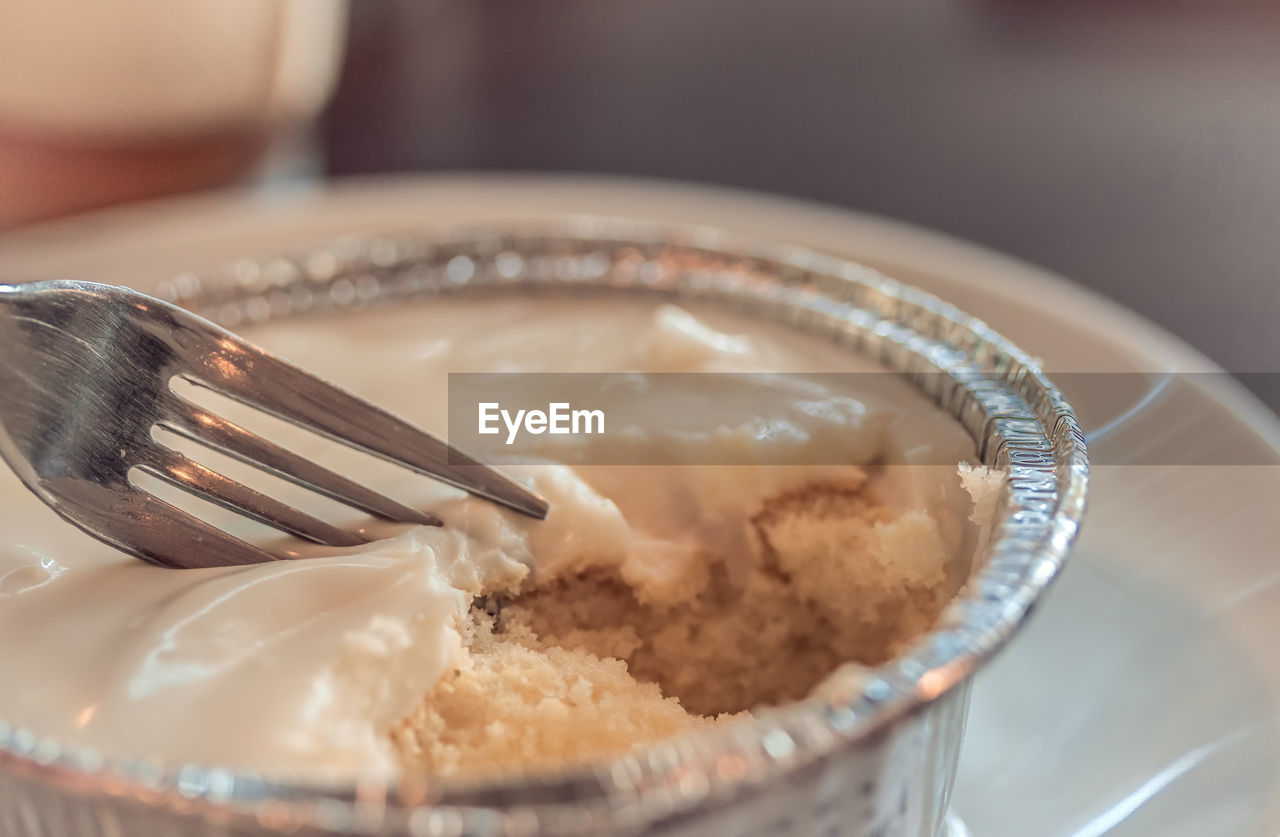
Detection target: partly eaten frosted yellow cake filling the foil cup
<box><xmin>0</xmin><ymin>298</ymin><xmax>1000</xmax><ymax>779</ymax></box>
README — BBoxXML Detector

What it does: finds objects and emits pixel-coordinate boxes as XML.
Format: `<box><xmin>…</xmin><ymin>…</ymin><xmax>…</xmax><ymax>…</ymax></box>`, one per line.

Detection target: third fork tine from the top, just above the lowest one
<box><xmin>137</xmin><ymin>449</ymin><xmax>367</xmax><ymax>546</ymax></box>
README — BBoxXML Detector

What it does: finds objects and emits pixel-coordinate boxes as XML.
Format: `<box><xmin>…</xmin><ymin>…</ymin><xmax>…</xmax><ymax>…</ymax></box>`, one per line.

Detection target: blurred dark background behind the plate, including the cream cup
<box><xmin>0</xmin><ymin>0</ymin><xmax>1280</xmax><ymax>406</ymax></box>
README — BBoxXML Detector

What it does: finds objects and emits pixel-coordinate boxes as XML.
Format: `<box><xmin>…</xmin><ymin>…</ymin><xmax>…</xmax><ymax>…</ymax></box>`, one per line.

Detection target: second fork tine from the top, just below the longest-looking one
<box><xmin>160</xmin><ymin>397</ymin><xmax>443</xmax><ymax>526</ymax></box>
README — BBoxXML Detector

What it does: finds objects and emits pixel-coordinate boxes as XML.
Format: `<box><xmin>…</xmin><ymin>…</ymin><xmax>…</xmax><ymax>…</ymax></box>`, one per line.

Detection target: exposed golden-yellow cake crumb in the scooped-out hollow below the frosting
<box><xmin>392</xmin><ymin>471</ymin><xmax>989</xmax><ymax>774</ymax></box>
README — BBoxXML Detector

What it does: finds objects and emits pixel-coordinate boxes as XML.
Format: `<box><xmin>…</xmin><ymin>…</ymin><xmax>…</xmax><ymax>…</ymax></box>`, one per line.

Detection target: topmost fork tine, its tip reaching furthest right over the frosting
<box><xmin>179</xmin><ymin>337</ymin><xmax>547</xmax><ymax>520</ymax></box>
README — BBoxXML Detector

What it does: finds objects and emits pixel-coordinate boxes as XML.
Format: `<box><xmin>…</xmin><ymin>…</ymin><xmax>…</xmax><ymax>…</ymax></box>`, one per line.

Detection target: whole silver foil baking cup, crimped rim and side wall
<box><xmin>0</xmin><ymin>218</ymin><xmax>1089</xmax><ymax>837</ymax></box>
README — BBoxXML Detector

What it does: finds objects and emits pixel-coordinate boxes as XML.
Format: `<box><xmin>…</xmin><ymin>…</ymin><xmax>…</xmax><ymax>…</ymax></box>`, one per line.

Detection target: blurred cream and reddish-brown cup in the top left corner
<box><xmin>0</xmin><ymin>0</ymin><xmax>346</xmax><ymax>227</ymax></box>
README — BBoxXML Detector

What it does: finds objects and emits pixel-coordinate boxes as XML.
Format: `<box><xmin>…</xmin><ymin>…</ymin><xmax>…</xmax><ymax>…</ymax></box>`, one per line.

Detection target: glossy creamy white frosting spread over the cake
<box><xmin>0</xmin><ymin>299</ymin><xmax>972</xmax><ymax>778</ymax></box>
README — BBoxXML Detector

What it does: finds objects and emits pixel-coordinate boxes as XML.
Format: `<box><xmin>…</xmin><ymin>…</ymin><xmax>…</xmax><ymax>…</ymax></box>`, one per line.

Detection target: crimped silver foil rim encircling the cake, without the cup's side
<box><xmin>0</xmin><ymin>216</ymin><xmax>1089</xmax><ymax>836</ymax></box>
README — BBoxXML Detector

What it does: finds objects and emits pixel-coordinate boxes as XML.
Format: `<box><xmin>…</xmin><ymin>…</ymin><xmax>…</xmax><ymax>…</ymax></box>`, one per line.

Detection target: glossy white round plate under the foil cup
<box><xmin>0</xmin><ymin>175</ymin><xmax>1280</xmax><ymax>837</ymax></box>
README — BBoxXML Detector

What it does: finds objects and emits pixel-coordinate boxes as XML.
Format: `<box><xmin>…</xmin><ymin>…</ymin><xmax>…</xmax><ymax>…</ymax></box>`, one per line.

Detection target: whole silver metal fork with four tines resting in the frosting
<box><xmin>0</xmin><ymin>282</ymin><xmax>547</xmax><ymax>567</ymax></box>
